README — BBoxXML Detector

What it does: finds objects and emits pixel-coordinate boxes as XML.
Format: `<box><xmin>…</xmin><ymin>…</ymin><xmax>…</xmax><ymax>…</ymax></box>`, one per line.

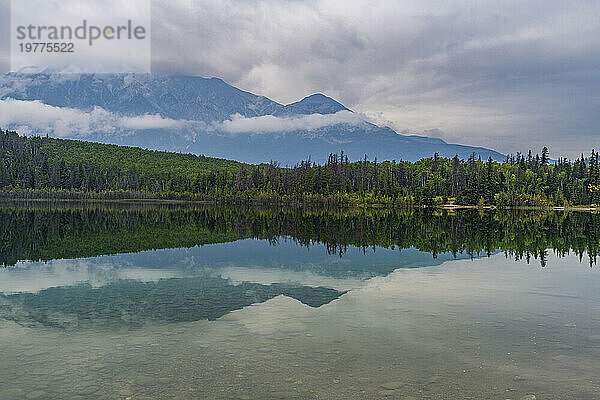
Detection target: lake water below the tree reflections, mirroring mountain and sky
<box><xmin>0</xmin><ymin>206</ymin><xmax>600</xmax><ymax>399</ymax></box>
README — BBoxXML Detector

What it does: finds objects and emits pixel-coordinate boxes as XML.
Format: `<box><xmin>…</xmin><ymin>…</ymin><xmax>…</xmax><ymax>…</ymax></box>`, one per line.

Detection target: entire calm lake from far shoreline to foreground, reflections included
<box><xmin>0</xmin><ymin>203</ymin><xmax>600</xmax><ymax>400</ymax></box>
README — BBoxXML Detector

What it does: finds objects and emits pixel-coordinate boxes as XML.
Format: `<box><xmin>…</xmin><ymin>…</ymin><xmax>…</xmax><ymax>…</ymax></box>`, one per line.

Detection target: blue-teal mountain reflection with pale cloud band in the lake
<box><xmin>0</xmin><ymin>239</ymin><xmax>468</xmax><ymax>329</ymax></box>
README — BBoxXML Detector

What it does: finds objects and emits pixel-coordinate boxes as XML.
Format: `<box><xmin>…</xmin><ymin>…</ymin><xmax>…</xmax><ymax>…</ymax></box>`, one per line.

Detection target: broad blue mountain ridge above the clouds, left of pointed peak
<box><xmin>0</xmin><ymin>74</ymin><xmax>284</xmax><ymax>121</ymax></box>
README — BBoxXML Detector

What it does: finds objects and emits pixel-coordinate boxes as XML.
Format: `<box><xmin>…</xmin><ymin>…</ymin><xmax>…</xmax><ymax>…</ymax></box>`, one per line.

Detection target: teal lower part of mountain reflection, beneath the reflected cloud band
<box><xmin>0</xmin><ymin>276</ymin><xmax>343</xmax><ymax>329</ymax></box>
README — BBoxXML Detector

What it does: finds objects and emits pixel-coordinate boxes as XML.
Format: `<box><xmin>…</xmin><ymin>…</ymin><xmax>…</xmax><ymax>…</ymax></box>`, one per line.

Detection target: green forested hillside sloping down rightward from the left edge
<box><xmin>0</xmin><ymin>131</ymin><xmax>241</xmax><ymax>193</ymax></box>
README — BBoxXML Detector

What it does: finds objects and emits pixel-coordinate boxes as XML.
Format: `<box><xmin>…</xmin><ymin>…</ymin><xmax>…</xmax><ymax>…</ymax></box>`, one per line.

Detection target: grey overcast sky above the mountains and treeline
<box><xmin>0</xmin><ymin>0</ymin><xmax>600</xmax><ymax>157</ymax></box>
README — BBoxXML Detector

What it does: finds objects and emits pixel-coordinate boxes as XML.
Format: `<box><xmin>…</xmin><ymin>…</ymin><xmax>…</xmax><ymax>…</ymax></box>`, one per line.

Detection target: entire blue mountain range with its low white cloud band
<box><xmin>0</xmin><ymin>73</ymin><xmax>504</xmax><ymax>165</ymax></box>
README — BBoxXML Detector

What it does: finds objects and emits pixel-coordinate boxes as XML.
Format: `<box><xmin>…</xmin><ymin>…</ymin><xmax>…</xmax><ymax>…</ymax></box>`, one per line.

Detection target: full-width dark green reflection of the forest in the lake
<box><xmin>0</xmin><ymin>202</ymin><xmax>600</xmax><ymax>266</ymax></box>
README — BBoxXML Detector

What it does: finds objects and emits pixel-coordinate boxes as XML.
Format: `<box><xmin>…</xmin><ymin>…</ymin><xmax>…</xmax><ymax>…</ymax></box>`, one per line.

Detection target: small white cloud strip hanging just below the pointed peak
<box><xmin>216</xmin><ymin>110</ymin><xmax>365</xmax><ymax>133</ymax></box>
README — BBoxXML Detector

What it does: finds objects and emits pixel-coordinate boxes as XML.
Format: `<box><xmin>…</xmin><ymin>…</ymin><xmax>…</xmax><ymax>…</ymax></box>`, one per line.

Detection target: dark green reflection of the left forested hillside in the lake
<box><xmin>0</xmin><ymin>206</ymin><xmax>250</xmax><ymax>265</ymax></box>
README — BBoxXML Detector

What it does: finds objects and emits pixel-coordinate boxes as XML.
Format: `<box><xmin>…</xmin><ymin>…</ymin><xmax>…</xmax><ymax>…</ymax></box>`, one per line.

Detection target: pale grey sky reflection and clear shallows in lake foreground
<box><xmin>0</xmin><ymin>254</ymin><xmax>600</xmax><ymax>400</ymax></box>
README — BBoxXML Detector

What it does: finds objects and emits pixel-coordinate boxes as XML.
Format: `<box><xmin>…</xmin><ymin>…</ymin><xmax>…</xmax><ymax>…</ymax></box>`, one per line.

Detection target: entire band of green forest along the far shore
<box><xmin>0</xmin><ymin>130</ymin><xmax>600</xmax><ymax>208</ymax></box>
